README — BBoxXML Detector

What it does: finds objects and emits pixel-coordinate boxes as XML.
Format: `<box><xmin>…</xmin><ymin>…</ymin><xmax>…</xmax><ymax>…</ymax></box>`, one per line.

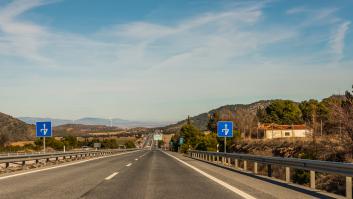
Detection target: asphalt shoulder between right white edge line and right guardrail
<box><xmin>167</xmin><ymin>152</ymin><xmax>344</xmax><ymax>199</ymax></box>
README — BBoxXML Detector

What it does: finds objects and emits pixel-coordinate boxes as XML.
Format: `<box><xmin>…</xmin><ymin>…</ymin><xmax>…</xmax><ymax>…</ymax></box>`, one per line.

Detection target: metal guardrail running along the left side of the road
<box><xmin>0</xmin><ymin>149</ymin><xmax>138</xmax><ymax>168</ymax></box>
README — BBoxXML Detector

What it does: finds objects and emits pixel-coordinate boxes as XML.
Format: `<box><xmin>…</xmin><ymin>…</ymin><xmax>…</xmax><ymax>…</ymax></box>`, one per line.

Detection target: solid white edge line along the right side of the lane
<box><xmin>162</xmin><ymin>151</ymin><xmax>256</xmax><ymax>199</ymax></box>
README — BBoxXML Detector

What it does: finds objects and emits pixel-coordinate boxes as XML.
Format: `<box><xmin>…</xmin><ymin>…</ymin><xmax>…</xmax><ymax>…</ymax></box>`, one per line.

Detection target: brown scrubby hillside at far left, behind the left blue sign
<box><xmin>0</xmin><ymin>113</ymin><xmax>35</xmax><ymax>146</ymax></box>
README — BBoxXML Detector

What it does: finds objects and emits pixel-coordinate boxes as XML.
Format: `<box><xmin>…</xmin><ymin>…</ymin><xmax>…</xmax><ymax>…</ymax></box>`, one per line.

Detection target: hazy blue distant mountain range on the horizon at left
<box><xmin>18</xmin><ymin>117</ymin><xmax>169</xmax><ymax>128</ymax></box>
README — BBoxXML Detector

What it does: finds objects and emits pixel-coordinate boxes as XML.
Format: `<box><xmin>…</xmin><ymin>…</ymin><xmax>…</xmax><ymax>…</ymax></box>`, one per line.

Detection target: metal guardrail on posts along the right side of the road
<box><xmin>188</xmin><ymin>150</ymin><xmax>353</xmax><ymax>198</ymax></box>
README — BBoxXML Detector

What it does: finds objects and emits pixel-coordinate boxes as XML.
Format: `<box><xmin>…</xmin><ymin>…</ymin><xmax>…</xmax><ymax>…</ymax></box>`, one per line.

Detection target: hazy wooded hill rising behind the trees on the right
<box><xmin>162</xmin><ymin>100</ymin><xmax>272</xmax><ymax>133</ymax></box>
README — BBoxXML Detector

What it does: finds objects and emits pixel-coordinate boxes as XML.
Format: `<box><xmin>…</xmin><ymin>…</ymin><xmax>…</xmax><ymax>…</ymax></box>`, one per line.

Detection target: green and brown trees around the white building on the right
<box><xmin>170</xmin><ymin>86</ymin><xmax>353</xmax><ymax>154</ymax></box>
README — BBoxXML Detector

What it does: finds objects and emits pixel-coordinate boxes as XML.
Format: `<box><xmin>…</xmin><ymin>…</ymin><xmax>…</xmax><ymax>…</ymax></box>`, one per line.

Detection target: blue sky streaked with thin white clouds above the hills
<box><xmin>0</xmin><ymin>0</ymin><xmax>353</xmax><ymax>121</ymax></box>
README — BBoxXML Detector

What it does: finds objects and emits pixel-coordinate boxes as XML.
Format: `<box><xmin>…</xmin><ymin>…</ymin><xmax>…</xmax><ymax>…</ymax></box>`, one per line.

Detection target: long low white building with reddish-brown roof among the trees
<box><xmin>259</xmin><ymin>124</ymin><xmax>313</xmax><ymax>139</ymax></box>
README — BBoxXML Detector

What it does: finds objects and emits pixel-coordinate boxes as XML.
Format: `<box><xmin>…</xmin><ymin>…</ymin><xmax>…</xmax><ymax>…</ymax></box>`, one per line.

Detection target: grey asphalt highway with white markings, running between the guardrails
<box><xmin>0</xmin><ymin>150</ymin><xmax>342</xmax><ymax>199</ymax></box>
